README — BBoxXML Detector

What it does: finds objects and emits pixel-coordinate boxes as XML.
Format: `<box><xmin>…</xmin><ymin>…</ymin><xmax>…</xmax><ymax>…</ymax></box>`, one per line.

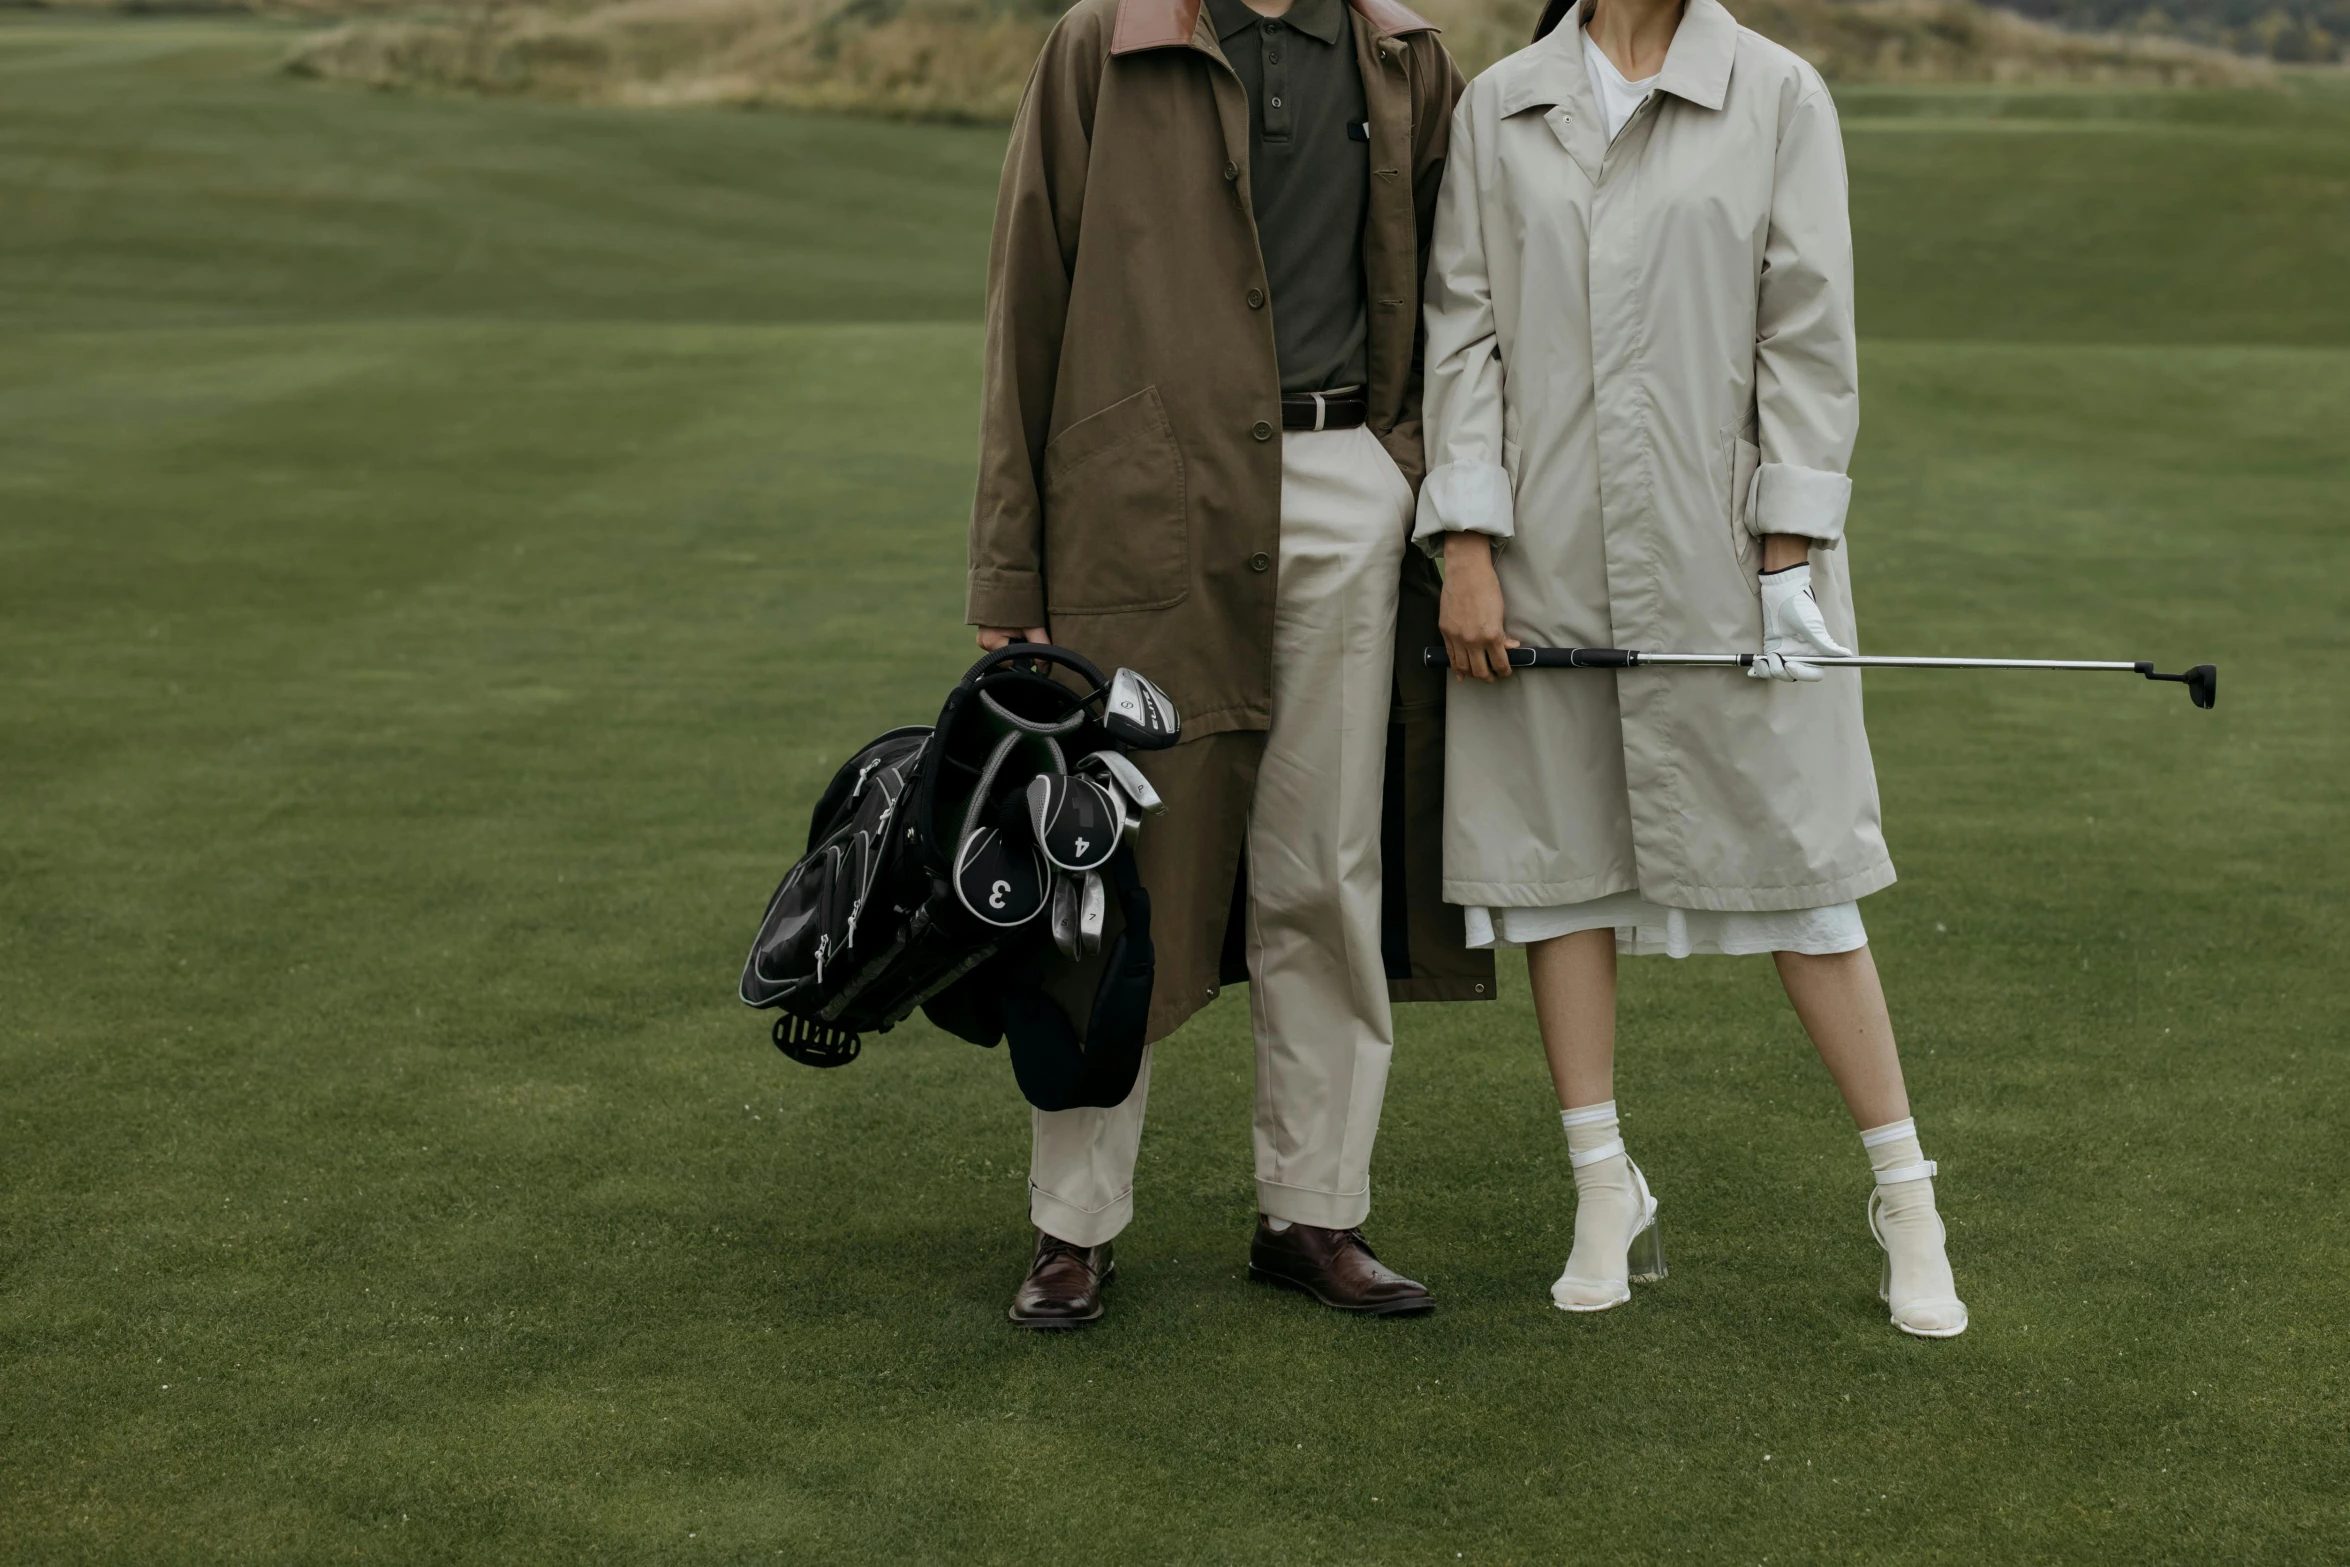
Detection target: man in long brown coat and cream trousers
<box><xmin>968</xmin><ymin>0</ymin><xmax>1495</xmax><ymax>1327</ymax></box>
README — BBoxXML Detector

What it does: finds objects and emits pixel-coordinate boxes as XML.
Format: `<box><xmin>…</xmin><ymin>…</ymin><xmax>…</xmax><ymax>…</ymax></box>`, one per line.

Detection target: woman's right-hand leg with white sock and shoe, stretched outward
<box><xmin>1772</xmin><ymin>947</ymin><xmax>1967</xmax><ymax>1339</ymax></box>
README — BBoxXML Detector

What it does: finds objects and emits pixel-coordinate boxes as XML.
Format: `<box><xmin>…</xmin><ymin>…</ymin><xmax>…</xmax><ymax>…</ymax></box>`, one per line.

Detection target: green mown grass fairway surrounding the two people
<box><xmin>0</xmin><ymin>16</ymin><xmax>2350</xmax><ymax>1565</ymax></box>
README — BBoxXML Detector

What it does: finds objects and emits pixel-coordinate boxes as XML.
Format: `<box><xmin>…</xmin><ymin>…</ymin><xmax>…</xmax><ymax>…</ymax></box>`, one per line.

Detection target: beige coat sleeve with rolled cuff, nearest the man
<box><xmin>1412</xmin><ymin>99</ymin><xmax>1518</xmax><ymax>554</ymax></box>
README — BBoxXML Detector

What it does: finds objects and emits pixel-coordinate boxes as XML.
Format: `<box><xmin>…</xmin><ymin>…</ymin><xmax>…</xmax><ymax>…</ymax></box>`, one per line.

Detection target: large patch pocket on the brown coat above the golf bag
<box><xmin>1043</xmin><ymin>385</ymin><xmax>1191</xmax><ymax>616</ymax></box>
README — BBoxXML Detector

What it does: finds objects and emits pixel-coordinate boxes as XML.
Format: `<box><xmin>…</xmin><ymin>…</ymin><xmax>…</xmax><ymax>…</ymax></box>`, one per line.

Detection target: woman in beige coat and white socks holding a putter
<box><xmin>1415</xmin><ymin>0</ymin><xmax>1967</xmax><ymax>1337</ymax></box>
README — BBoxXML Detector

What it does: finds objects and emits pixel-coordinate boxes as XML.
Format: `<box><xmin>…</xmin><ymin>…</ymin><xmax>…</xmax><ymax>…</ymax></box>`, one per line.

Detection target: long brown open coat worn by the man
<box><xmin>966</xmin><ymin>0</ymin><xmax>1495</xmax><ymax>1038</ymax></box>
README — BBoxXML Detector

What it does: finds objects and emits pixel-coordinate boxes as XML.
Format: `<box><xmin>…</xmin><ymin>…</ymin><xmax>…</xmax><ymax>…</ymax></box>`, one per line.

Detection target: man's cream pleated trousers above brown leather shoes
<box><xmin>1029</xmin><ymin>430</ymin><xmax>1412</xmax><ymax>1245</ymax></box>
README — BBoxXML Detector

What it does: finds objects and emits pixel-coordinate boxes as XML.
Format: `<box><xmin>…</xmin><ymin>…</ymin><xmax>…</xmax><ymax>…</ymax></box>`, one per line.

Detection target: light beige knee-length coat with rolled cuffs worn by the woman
<box><xmin>1417</xmin><ymin>0</ymin><xmax>1894</xmax><ymax>909</ymax></box>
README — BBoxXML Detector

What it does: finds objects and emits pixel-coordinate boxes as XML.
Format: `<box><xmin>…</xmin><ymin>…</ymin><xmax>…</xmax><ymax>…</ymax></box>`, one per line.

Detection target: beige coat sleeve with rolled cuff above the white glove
<box><xmin>1746</xmin><ymin>87</ymin><xmax>1861</xmax><ymax>550</ymax></box>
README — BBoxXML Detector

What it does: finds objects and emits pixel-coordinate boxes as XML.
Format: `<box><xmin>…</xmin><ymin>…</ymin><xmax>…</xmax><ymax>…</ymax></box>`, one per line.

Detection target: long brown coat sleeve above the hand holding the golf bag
<box><xmin>964</xmin><ymin>23</ymin><xmax>1100</xmax><ymax>627</ymax></box>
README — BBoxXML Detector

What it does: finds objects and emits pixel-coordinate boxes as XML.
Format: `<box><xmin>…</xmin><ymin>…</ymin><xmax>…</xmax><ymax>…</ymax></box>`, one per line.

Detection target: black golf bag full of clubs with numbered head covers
<box><xmin>740</xmin><ymin>644</ymin><xmax>1177</xmax><ymax>1109</ymax></box>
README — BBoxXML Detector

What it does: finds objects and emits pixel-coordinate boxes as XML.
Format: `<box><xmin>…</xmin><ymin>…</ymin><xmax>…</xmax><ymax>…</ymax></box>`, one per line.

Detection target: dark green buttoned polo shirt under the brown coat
<box><xmin>1208</xmin><ymin>0</ymin><xmax>1370</xmax><ymax>392</ymax></box>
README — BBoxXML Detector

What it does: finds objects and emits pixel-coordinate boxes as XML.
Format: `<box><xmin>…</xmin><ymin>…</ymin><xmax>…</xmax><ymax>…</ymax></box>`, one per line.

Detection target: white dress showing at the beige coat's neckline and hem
<box><xmin>1464</xmin><ymin>31</ymin><xmax>1868</xmax><ymax>959</ymax></box>
